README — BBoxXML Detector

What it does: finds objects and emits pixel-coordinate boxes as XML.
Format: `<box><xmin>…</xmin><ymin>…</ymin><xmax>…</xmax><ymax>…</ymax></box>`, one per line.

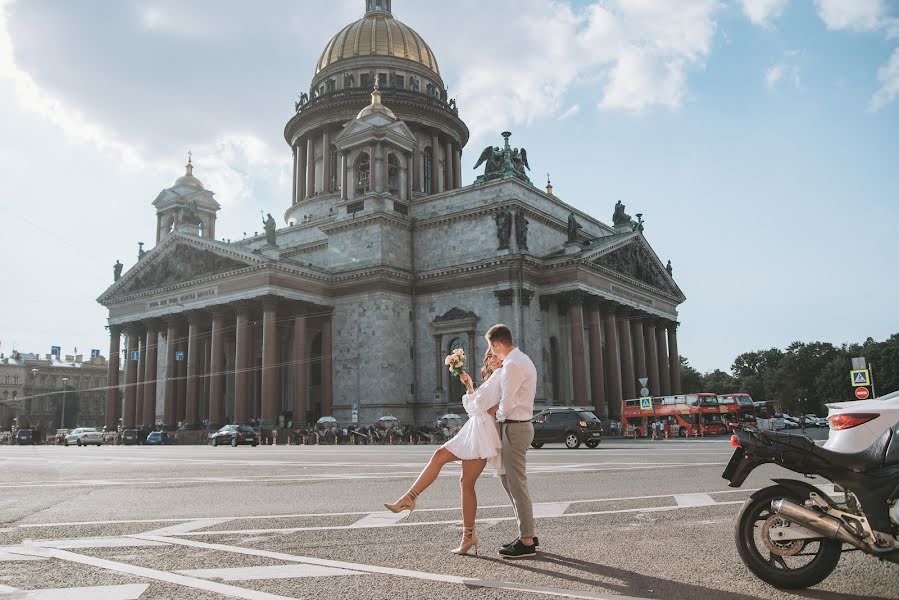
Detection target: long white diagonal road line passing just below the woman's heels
<box><xmin>132</xmin><ymin>535</ymin><xmax>636</xmax><ymax>600</ymax></box>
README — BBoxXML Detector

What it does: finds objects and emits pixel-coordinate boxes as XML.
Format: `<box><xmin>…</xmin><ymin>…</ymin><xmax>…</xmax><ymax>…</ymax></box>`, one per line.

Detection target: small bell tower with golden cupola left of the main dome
<box><xmin>153</xmin><ymin>157</ymin><xmax>221</xmax><ymax>244</ymax></box>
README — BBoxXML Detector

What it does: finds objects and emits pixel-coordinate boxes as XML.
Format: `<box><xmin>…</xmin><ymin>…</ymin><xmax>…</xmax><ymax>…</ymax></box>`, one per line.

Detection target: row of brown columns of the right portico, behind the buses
<box><xmin>540</xmin><ymin>291</ymin><xmax>681</xmax><ymax>419</ymax></box>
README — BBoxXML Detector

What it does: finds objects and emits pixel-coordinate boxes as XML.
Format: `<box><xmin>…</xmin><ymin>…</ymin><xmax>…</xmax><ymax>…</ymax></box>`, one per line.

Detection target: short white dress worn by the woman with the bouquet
<box><xmin>443</xmin><ymin>372</ymin><xmax>502</xmax><ymax>471</ymax></box>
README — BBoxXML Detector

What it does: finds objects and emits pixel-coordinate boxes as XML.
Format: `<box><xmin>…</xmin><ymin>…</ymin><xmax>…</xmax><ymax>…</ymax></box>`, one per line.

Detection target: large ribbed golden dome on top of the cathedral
<box><xmin>315</xmin><ymin>10</ymin><xmax>440</xmax><ymax>76</ymax></box>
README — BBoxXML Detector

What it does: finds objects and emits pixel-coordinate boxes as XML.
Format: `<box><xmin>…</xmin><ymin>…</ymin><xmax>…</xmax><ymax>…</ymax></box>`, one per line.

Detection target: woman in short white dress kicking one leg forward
<box><xmin>384</xmin><ymin>348</ymin><xmax>503</xmax><ymax>554</ymax></box>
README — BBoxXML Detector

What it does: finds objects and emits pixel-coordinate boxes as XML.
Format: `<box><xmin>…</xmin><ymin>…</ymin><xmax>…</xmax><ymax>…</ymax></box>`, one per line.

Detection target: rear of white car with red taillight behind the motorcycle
<box><xmin>824</xmin><ymin>391</ymin><xmax>899</xmax><ymax>452</ymax></box>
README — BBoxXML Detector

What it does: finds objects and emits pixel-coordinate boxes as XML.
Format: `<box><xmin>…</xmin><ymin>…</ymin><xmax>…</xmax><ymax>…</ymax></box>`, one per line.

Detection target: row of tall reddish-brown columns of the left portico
<box><xmin>106</xmin><ymin>297</ymin><xmax>334</xmax><ymax>429</ymax></box>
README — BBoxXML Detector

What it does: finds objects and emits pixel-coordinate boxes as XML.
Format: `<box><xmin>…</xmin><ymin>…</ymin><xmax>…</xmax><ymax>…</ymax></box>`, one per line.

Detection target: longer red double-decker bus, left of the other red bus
<box><xmin>621</xmin><ymin>394</ymin><xmax>725</xmax><ymax>437</ymax></box>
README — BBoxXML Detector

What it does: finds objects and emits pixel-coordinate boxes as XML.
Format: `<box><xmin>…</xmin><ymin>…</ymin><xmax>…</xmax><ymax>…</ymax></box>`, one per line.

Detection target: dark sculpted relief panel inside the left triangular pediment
<box><xmin>121</xmin><ymin>246</ymin><xmax>248</xmax><ymax>294</ymax></box>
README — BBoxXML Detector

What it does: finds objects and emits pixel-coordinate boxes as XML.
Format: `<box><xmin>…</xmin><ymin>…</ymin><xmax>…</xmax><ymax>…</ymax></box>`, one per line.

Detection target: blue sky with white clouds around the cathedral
<box><xmin>0</xmin><ymin>0</ymin><xmax>899</xmax><ymax>371</ymax></box>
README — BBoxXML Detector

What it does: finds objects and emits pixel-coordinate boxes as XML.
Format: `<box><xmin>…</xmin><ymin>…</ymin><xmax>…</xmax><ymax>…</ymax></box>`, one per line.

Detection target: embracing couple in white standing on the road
<box><xmin>384</xmin><ymin>325</ymin><xmax>538</xmax><ymax>558</ymax></box>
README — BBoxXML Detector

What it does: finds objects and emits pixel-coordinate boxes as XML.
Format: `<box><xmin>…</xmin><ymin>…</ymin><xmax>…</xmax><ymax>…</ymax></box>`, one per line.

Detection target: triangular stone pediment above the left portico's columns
<box><xmin>98</xmin><ymin>234</ymin><xmax>261</xmax><ymax>304</ymax></box>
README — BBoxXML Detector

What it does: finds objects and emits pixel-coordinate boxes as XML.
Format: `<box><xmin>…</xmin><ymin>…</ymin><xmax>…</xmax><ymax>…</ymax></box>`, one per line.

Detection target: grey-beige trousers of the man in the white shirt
<box><xmin>500</xmin><ymin>423</ymin><xmax>534</xmax><ymax>538</ymax></box>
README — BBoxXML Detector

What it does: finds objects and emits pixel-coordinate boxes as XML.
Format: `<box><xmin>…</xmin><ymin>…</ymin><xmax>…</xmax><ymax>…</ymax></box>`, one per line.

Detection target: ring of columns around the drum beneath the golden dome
<box><xmin>292</xmin><ymin>127</ymin><xmax>462</xmax><ymax>204</ymax></box>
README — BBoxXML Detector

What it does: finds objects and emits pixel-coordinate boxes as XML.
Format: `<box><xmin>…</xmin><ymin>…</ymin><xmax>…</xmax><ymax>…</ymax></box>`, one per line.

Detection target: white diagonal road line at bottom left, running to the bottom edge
<box><xmin>7</xmin><ymin>548</ymin><xmax>293</xmax><ymax>600</ymax></box>
